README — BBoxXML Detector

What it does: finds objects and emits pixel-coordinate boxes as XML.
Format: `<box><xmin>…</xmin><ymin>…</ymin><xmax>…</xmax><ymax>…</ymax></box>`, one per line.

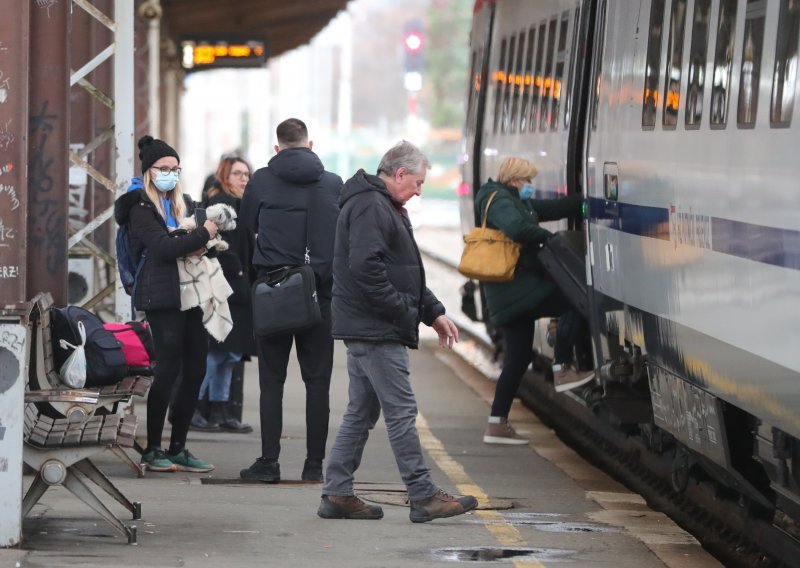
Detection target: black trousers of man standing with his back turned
<box><xmin>256</xmin><ymin>298</ymin><xmax>333</xmax><ymax>460</ymax></box>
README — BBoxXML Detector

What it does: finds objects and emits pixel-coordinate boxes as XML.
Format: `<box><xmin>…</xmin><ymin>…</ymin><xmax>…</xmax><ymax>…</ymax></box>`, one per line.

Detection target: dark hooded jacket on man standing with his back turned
<box><xmin>240</xmin><ymin>148</ymin><xmax>342</xmax><ymax>298</ymax></box>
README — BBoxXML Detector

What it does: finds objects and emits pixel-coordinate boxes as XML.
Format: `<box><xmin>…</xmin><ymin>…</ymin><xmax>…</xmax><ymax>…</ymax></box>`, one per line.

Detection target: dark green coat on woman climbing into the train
<box><xmin>475</xmin><ymin>179</ymin><xmax>582</xmax><ymax>326</ymax></box>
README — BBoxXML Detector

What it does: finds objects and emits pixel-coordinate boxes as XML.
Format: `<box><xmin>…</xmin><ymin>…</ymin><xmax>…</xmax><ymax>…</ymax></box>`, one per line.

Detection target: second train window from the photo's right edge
<box><xmin>736</xmin><ymin>0</ymin><xmax>767</xmax><ymax>128</ymax></box>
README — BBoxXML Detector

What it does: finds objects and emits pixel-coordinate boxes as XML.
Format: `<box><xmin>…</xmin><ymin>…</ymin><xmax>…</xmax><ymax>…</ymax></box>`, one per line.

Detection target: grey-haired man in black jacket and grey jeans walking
<box><xmin>317</xmin><ymin>141</ymin><xmax>478</xmax><ymax>523</ymax></box>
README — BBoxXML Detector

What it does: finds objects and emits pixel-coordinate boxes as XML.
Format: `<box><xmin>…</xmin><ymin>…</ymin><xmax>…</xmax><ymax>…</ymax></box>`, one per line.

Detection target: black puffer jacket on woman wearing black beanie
<box><xmin>114</xmin><ymin>184</ymin><xmax>209</xmax><ymax>312</ymax></box>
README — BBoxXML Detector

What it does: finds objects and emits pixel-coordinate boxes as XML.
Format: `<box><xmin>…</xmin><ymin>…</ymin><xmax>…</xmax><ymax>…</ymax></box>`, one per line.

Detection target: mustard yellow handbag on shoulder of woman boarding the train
<box><xmin>458</xmin><ymin>191</ymin><xmax>520</xmax><ymax>282</ymax></box>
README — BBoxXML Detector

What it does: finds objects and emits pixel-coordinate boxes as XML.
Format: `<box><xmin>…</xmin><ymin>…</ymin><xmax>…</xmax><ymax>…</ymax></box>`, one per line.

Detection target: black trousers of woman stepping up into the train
<box><xmin>491</xmin><ymin>290</ymin><xmax>584</xmax><ymax>418</ymax></box>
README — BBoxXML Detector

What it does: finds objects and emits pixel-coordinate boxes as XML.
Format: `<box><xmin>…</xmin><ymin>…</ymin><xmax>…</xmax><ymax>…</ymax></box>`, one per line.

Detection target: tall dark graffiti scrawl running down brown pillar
<box><xmin>28</xmin><ymin>101</ymin><xmax>67</xmax><ymax>273</ymax></box>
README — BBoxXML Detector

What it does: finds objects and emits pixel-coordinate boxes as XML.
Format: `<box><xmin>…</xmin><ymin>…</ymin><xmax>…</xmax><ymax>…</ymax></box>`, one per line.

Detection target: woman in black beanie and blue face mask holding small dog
<box><xmin>114</xmin><ymin>136</ymin><xmax>218</xmax><ymax>472</ymax></box>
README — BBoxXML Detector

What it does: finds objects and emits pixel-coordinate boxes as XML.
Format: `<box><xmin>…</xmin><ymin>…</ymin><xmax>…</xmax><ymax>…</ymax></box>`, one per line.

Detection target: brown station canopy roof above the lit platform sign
<box><xmin>161</xmin><ymin>0</ymin><xmax>348</xmax><ymax>57</ymax></box>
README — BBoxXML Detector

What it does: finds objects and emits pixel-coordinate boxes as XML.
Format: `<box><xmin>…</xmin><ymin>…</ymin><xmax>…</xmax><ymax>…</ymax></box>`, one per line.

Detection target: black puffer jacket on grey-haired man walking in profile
<box><xmin>332</xmin><ymin>170</ymin><xmax>445</xmax><ymax>349</ymax></box>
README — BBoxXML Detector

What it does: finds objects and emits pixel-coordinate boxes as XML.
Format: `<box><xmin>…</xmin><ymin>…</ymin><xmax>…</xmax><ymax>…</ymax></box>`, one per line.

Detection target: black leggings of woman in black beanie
<box><xmin>146</xmin><ymin>308</ymin><xmax>208</xmax><ymax>454</ymax></box>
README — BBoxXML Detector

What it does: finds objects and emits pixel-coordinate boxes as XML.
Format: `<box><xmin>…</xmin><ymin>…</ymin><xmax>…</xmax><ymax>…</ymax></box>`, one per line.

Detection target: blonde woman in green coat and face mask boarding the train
<box><xmin>475</xmin><ymin>158</ymin><xmax>593</xmax><ymax>445</ymax></box>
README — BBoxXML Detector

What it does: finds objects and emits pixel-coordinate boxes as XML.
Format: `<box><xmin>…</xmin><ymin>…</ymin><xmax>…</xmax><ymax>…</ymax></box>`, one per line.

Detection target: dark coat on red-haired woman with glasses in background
<box><xmin>207</xmin><ymin>191</ymin><xmax>256</xmax><ymax>355</ymax></box>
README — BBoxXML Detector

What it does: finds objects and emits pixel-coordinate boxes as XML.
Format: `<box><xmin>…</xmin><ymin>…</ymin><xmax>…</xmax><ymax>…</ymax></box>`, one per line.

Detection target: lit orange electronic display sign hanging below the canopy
<box><xmin>181</xmin><ymin>39</ymin><xmax>267</xmax><ymax>71</ymax></box>
